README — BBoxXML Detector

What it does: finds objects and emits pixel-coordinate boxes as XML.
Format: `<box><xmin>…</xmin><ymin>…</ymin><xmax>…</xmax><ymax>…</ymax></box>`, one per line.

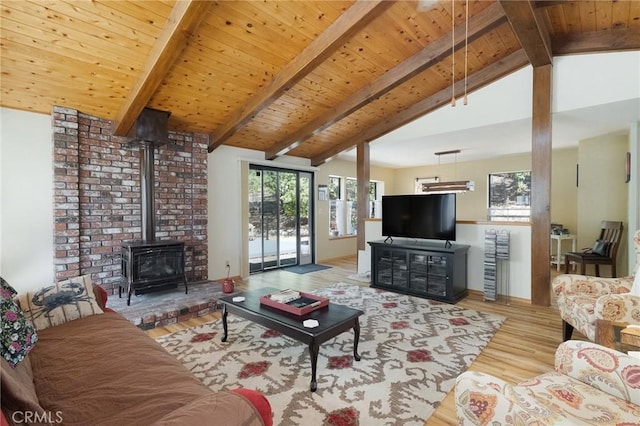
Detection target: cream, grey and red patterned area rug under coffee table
<box><xmin>158</xmin><ymin>283</ymin><xmax>504</xmax><ymax>426</ymax></box>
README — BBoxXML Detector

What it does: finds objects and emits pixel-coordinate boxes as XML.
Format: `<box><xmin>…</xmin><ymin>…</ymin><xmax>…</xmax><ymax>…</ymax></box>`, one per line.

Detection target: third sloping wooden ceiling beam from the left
<box><xmin>266</xmin><ymin>3</ymin><xmax>506</xmax><ymax>160</ymax></box>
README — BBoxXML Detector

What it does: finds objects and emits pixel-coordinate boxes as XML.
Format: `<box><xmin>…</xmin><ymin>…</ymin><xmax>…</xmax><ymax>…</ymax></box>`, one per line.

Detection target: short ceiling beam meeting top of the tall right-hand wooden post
<box><xmin>500</xmin><ymin>0</ymin><xmax>553</xmax><ymax>67</ymax></box>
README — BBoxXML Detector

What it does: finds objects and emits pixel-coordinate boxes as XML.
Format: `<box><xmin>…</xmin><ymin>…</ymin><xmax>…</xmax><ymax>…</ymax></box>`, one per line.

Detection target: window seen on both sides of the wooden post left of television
<box><xmin>328</xmin><ymin>176</ymin><xmax>383</xmax><ymax>237</ymax></box>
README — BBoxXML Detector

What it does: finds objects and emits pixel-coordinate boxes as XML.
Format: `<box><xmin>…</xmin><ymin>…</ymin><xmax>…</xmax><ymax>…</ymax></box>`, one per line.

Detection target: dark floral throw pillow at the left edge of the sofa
<box><xmin>0</xmin><ymin>277</ymin><xmax>38</xmax><ymax>367</ymax></box>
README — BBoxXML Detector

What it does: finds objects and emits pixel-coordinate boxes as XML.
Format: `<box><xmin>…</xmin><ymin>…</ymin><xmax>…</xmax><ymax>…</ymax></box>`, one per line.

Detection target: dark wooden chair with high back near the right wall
<box><xmin>564</xmin><ymin>220</ymin><xmax>623</xmax><ymax>278</ymax></box>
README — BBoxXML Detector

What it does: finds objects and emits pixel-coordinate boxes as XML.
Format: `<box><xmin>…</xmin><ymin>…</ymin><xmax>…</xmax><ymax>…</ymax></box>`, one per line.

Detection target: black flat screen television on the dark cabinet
<box><xmin>382</xmin><ymin>194</ymin><xmax>456</xmax><ymax>241</ymax></box>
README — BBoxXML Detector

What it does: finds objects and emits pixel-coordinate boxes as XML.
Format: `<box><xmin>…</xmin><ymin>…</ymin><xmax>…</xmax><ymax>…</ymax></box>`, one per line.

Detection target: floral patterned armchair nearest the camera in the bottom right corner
<box><xmin>455</xmin><ymin>340</ymin><xmax>640</xmax><ymax>426</ymax></box>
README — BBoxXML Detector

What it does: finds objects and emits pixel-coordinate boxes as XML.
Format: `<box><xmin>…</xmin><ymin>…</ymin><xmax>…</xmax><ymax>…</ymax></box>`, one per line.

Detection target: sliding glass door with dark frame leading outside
<box><xmin>249</xmin><ymin>165</ymin><xmax>313</xmax><ymax>273</ymax></box>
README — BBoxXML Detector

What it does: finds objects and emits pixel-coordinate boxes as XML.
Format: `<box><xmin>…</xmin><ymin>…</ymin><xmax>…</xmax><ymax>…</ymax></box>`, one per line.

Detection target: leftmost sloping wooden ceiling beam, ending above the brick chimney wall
<box><xmin>113</xmin><ymin>0</ymin><xmax>212</xmax><ymax>136</ymax></box>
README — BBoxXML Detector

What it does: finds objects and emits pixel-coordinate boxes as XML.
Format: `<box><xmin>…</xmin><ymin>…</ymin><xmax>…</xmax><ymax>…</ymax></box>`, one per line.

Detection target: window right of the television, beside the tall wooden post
<box><xmin>487</xmin><ymin>170</ymin><xmax>531</xmax><ymax>222</ymax></box>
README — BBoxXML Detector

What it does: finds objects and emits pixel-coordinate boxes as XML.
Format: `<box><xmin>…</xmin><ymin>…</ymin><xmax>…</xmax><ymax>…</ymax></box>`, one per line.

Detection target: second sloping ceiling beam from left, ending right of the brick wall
<box><xmin>209</xmin><ymin>0</ymin><xmax>394</xmax><ymax>152</ymax></box>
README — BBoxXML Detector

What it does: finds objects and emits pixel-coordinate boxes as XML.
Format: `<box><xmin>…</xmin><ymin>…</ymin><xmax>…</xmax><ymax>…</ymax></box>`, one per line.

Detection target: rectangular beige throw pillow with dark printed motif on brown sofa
<box><xmin>18</xmin><ymin>275</ymin><xmax>104</xmax><ymax>330</ymax></box>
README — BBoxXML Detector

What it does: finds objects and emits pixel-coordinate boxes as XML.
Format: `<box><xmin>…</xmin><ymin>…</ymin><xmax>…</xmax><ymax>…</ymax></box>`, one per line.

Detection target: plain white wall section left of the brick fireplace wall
<box><xmin>0</xmin><ymin>108</ymin><xmax>54</xmax><ymax>291</ymax></box>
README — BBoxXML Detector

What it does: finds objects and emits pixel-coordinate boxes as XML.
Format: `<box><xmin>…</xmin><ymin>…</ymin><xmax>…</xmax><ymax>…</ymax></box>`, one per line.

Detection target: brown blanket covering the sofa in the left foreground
<box><xmin>23</xmin><ymin>313</ymin><xmax>262</xmax><ymax>426</ymax></box>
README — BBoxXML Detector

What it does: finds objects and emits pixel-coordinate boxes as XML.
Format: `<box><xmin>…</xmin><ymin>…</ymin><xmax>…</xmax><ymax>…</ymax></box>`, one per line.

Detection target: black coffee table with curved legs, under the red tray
<box><xmin>219</xmin><ymin>288</ymin><xmax>364</xmax><ymax>392</ymax></box>
